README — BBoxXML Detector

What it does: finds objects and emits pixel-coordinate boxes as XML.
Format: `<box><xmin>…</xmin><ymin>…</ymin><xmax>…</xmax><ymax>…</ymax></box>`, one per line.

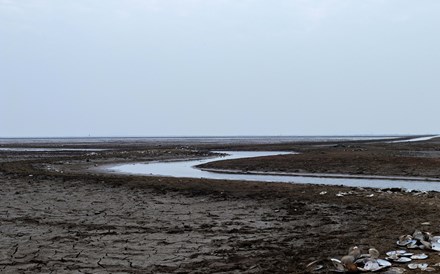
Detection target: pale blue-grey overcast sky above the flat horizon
<box><xmin>0</xmin><ymin>0</ymin><xmax>440</xmax><ymax>137</ymax></box>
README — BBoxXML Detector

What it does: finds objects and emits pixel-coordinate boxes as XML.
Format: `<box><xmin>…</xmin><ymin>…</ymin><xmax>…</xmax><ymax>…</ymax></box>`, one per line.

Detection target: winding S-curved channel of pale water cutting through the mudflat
<box><xmin>106</xmin><ymin>151</ymin><xmax>440</xmax><ymax>191</ymax></box>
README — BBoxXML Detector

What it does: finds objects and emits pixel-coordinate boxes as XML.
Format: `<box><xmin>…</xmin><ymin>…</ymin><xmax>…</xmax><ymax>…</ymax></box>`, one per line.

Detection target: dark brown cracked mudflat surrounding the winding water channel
<box><xmin>0</xmin><ymin>139</ymin><xmax>440</xmax><ymax>273</ymax></box>
